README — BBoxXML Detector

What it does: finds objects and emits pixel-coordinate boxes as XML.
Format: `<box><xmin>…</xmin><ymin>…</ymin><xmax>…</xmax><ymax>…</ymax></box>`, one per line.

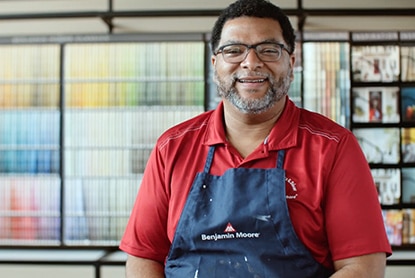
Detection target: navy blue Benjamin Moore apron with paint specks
<box><xmin>165</xmin><ymin>146</ymin><xmax>332</xmax><ymax>278</ymax></box>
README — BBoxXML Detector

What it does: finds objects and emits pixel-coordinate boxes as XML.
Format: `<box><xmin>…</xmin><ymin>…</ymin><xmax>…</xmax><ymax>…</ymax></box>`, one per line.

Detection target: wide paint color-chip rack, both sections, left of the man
<box><xmin>0</xmin><ymin>32</ymin><xmax>205</xmax><ymax>248</ymax></box>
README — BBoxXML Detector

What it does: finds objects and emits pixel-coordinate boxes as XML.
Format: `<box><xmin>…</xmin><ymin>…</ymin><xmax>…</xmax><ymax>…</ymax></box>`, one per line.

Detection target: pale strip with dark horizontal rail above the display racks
<box><xmin>0</xmin><ymin>0</ymin><xmax>415</xmax><ymax>36</ymax></box>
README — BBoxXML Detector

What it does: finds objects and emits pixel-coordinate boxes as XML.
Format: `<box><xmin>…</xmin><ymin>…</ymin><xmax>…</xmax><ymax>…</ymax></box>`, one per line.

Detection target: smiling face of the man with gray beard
<box><xmin>212</xmin><ymin>17</ymin><xmax>295</xmax><ymax>114</ymax></box>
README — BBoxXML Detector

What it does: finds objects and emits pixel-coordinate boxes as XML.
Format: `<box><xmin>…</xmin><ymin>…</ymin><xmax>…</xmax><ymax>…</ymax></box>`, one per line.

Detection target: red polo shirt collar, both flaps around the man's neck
<box><xmin>204</xmin><ymin>96</ymin><xmax>300</xmax><ymax>150</ymax></box>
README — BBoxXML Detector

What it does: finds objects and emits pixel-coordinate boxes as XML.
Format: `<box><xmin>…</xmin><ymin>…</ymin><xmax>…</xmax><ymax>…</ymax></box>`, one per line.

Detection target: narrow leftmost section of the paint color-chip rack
<box><xmin>0</xmin><ymin>44</ymin><xmax>61</xmax><ymax>245</ymax></box>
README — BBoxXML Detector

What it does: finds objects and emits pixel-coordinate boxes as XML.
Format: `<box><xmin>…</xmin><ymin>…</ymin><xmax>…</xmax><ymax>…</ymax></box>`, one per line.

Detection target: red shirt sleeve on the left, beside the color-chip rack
<box><xmin>120</xmin><ymin>147</ymin><xmax>170</xmax><ymax>263</ymax></box>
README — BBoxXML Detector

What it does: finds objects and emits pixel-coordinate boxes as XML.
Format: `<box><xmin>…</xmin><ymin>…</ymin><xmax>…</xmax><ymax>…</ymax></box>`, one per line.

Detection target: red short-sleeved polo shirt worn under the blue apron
<box><xmin>120</xmin><ymin>99</ymin><xmax>391</xmax><ymax>268</ymax></box>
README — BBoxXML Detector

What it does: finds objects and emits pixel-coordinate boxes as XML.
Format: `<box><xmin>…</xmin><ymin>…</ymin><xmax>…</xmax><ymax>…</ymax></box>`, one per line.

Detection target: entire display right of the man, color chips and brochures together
<box><xmin>294</xmin><ymin>32</ymin><xmax>415</xmax><ymax>250</ymax></box>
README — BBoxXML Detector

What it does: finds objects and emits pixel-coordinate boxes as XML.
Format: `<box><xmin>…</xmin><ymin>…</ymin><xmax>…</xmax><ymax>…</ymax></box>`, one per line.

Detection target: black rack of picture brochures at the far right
<box><xmin>350</xmin><ymin>32</ymin><xmax>415</xmax><ymax>248</ymax></box>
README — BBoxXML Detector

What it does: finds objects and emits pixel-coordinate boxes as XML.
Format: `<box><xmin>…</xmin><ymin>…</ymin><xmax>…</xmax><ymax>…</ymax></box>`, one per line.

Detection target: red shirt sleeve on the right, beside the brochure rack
<box><xmin>325</xmin><ymin>133</ymin><xmax>391</xmax><ymax>260</ymax></box>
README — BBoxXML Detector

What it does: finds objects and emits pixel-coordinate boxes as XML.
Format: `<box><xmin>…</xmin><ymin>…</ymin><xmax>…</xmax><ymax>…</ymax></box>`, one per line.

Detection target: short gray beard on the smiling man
<box><xmin>214</xmin><ymin>70</ymin><xmax>291</xmax><ymax>114</ymax></box>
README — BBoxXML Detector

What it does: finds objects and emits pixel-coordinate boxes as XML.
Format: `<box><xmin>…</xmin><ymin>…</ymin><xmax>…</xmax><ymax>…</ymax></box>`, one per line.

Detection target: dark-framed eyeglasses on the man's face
<box><xmin>214</xmin><ymin>42</ymin><xmax>291</xmax><ymax>64</ymax></box>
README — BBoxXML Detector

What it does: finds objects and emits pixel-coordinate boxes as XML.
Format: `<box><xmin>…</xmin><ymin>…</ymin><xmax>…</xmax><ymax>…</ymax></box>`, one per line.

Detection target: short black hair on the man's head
<box><xmin>210</xmin><ymin>0</ymin><xmax>295</xmax><ymax>53</ymax></box>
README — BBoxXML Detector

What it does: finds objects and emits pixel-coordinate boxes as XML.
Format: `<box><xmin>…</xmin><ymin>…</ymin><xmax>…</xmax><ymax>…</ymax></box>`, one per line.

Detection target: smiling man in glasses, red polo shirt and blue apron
<box><xmin>120</xmin><ymin>0</ymin><xmax>391</xmax><ymax>278</ymax></box>
